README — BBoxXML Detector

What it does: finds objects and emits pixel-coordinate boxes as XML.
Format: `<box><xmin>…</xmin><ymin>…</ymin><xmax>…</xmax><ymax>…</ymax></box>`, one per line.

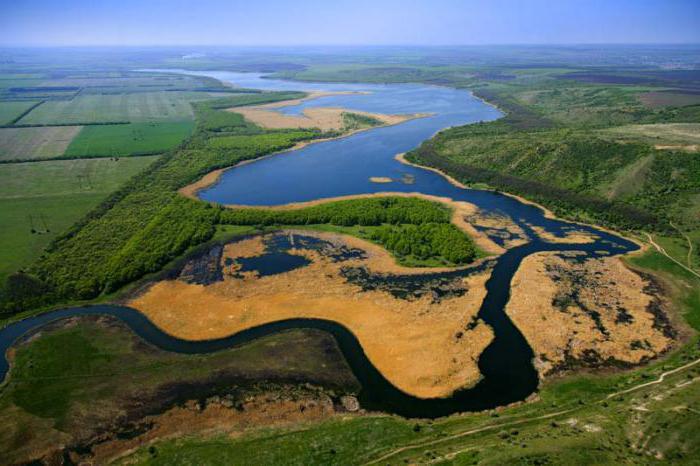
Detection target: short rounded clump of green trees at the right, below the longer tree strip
<box><xmin>369</xmin><ymin>223</ymin><xmax>476</xmax><ymax>264</ymax></box>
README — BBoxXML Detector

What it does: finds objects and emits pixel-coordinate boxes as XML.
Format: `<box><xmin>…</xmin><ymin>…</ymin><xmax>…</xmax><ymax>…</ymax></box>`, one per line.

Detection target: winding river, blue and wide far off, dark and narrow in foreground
<box><xmin>0</xmin><ymin>71</ymin><xmax>637</xmax><ymax>418</ymax></box>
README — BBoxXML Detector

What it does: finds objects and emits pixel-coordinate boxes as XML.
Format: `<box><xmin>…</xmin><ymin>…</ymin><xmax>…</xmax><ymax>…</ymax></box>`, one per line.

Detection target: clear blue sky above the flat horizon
<box><xmin>0</xmin><ymin>0</ymin><xmax>700</xmax><ymax>46</ymax></box>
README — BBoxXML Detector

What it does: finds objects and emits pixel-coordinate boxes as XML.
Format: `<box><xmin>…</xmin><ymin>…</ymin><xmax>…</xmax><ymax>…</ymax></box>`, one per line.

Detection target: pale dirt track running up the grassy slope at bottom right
<box><xmin>364</xmin><ymin>359</ymin><xmax>700</xmax><ymax>465</ymax></box>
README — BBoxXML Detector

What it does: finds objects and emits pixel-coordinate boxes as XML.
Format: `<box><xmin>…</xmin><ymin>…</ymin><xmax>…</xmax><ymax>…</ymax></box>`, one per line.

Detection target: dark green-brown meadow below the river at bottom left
<box><xmin>0</xmin><ymin>317</ymin><xmax>357</xmax><ymax>464</ymax></box>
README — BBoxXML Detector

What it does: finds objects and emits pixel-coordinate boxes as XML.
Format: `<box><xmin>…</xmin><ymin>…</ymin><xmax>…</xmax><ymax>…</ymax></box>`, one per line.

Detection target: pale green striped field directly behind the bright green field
<box><xmin>18</xmin><ymin>92</ymin><xmax>208</xmax><ymax>124</ymax></box>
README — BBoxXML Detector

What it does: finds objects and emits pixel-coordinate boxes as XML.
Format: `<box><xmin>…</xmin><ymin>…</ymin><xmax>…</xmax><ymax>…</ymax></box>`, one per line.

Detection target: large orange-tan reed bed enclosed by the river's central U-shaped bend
<box><xmin>129</xmin><ymin>233</ymin><xmax>492</xmax><ymax>398</ymax></box>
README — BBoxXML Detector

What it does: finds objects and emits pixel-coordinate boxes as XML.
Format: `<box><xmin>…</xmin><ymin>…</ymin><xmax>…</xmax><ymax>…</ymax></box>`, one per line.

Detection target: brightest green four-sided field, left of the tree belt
<box><xmin>64</xmin><ymin>121</ymin><xmax>194</xmax><ymax>157</ymax></box>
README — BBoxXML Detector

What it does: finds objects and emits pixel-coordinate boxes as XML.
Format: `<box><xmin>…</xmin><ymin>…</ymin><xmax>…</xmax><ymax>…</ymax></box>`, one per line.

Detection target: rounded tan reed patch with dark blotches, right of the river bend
<box><xmin>506</xmin><ymin>252</ymin><xmax>673</xmax><ymax>375</ymax></box>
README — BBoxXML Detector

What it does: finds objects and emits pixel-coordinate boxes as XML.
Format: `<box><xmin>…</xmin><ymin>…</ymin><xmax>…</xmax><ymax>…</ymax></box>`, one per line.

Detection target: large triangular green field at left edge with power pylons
<box><xmin>0</xmin><ymin>157</ymin><xmax>155</xmax><ymax>279</ymax></box>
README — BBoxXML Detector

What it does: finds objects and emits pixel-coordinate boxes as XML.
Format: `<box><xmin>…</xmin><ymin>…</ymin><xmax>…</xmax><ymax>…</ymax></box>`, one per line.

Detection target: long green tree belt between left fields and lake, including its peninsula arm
<box><xmin>0</xmin><ymin>92</ymin><xmax>476</xmax><ymax>315</ymax></box>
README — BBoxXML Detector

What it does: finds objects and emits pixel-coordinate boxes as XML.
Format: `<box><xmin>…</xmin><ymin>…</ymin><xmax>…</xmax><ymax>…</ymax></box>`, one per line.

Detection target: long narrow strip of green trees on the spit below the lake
<box><xmin>219</xmin><ymin>197</ymin><xmax>451</xmax><ymax>226</ymax></box>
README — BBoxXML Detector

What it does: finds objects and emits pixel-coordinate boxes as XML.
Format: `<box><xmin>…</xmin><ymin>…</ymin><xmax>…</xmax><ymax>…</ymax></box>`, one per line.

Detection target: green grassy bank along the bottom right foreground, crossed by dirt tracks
<box><xmin>116</xmin><ymin>252</ymin><xmax>700</xmax><ymax>465</ymax></box>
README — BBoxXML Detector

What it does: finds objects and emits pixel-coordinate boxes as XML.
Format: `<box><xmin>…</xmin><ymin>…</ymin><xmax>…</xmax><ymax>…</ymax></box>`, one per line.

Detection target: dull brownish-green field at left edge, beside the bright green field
<box><xmin>0</xmin><ymin>126</ymin><xmax>82</xmax><ymax>160</ymax></box>
